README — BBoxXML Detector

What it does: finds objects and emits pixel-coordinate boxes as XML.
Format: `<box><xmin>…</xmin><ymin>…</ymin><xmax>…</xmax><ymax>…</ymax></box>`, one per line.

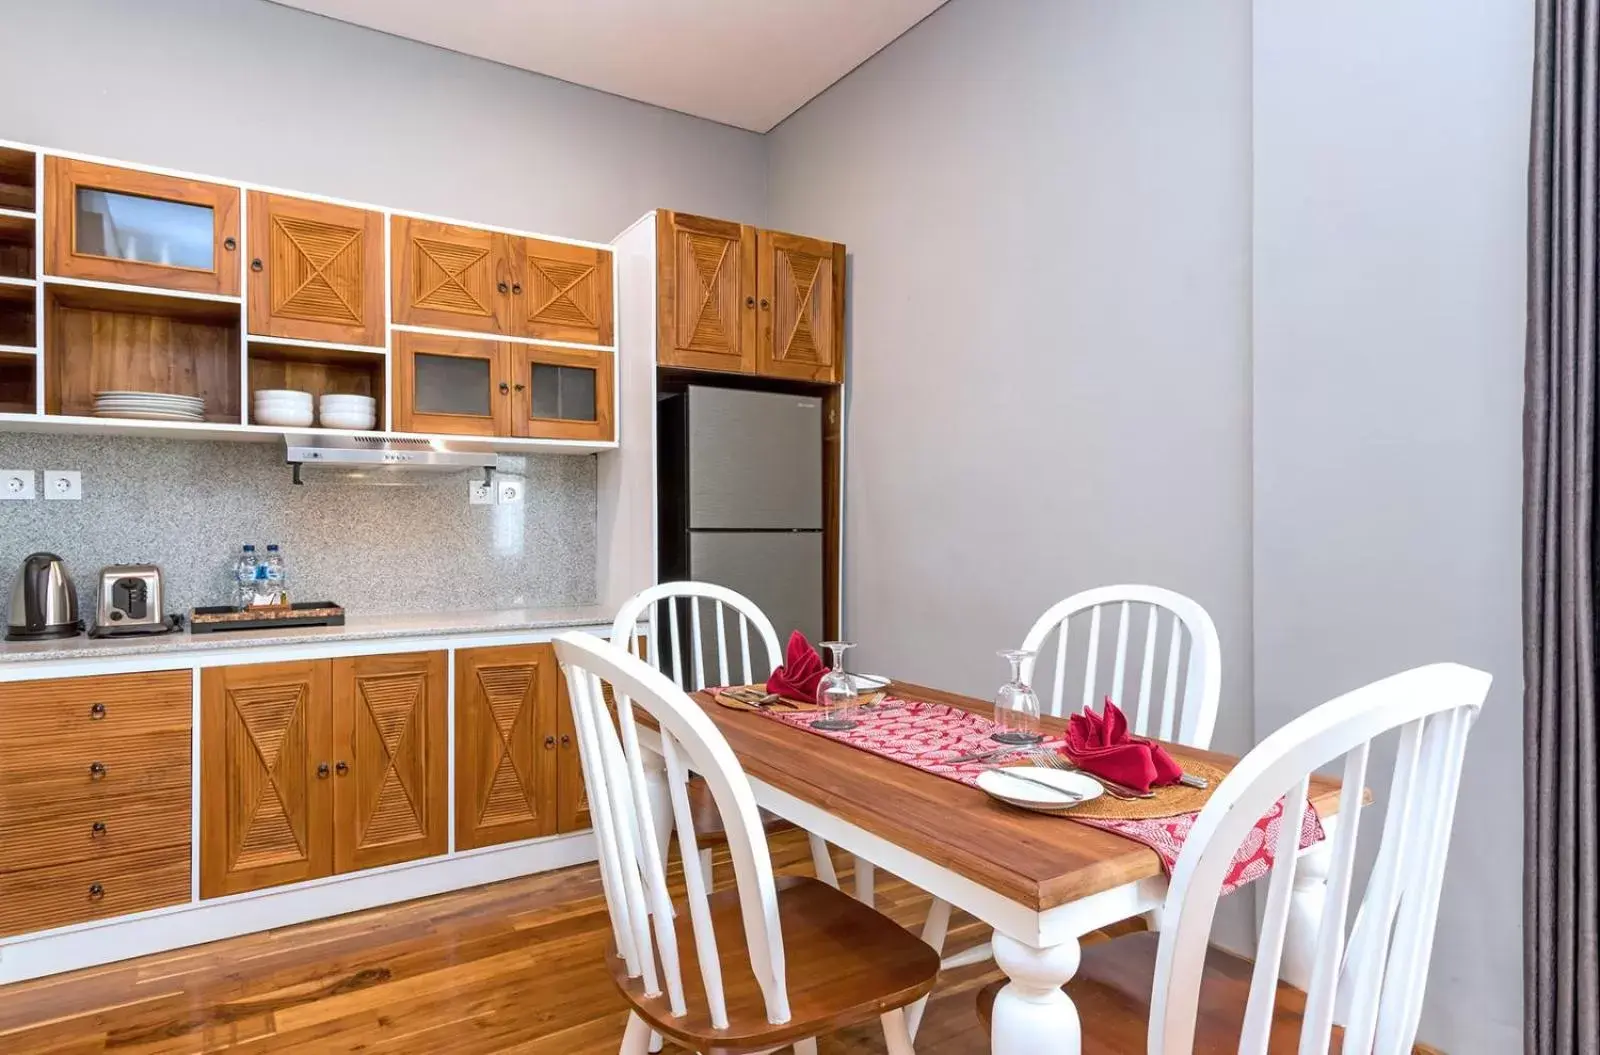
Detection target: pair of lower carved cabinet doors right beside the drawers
<box><xmin>200</xmin><ymin>653</ymin><xmax>448</xmax><ymax>898</ymax></box>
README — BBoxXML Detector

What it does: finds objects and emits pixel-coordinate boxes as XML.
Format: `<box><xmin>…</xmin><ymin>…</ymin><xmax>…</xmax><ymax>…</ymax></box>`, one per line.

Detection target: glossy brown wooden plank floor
<box><xmin>0</xmin><ymin>832</ymin><xmax>998</xmax><ymax>1055</ymax></box>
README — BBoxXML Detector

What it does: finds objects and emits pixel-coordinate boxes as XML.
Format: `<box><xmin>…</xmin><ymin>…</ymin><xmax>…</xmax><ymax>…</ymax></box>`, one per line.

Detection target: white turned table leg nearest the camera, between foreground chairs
<box><xmin>989</xmin><ymin>930</ymin><xmax>1083</xmax><ymax>1055</ymax></box>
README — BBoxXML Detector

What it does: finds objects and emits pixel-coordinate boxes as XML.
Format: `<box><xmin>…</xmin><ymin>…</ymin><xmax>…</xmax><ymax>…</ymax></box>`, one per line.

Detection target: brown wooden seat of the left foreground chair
<box><xmin>606</xmin><ymin>876</ymin><xmax>939</xmax><ymax>1055</ymax></box>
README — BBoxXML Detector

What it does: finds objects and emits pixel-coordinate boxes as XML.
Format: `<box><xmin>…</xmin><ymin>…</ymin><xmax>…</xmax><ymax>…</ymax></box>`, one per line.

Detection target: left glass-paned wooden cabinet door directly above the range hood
<box><xmin>394</xmin><ymin>333</ymin><xmax>512</xmax><ymax>435</ymax></box>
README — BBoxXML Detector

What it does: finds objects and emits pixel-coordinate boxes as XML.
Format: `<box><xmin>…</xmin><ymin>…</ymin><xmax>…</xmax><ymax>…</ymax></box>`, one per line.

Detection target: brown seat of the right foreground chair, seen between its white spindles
<box><xmin>978</xmin><ymin>933</ymin><xmax>1344</xmax><ymax>1055</ymax></box>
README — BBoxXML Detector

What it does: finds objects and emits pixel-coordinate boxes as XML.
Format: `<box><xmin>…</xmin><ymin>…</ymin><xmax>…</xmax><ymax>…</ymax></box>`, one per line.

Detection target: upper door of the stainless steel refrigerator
<box><xmin>688</xmin><ymin>386</ymin><xmax>822</xmax><ymax>530</ymax></box>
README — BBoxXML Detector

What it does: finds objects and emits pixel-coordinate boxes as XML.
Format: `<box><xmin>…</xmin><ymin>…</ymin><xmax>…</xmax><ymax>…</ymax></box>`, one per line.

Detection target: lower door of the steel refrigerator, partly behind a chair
<box><xmin>690</xmin><ymin>532</ymin><xmax>822</xmax><ymax>659</ymax></box>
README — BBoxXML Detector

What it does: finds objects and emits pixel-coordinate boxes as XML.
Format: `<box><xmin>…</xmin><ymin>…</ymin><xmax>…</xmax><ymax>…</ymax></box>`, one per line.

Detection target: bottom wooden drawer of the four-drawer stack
<box><xmin>0</xmin><ymin>842</ymin><xmax>190</xmax><ymax>935</ymax></box>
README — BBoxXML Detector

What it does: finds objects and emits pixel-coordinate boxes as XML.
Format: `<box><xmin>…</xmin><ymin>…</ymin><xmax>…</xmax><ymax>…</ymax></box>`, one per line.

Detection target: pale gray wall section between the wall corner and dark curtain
<box><xmin>1254</xmin><ymin>0</ymin><xmax>1533</xmax><ymax>1055</ymax></box>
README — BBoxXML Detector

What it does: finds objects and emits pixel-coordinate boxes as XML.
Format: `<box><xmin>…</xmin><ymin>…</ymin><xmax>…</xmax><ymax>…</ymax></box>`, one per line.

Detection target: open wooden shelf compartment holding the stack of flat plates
<box><xmin>43</xmin><ymin>285</ymin><xmax>242</xmax><ymax>424</ymax></box>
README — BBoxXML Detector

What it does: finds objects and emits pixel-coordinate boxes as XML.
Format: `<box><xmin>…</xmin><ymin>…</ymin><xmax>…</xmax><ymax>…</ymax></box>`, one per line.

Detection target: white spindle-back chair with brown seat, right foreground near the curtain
<box><xmin>979</xmin><ymin>663</ymin><xmax>1490</xmax><ymax>1055</ymax></box>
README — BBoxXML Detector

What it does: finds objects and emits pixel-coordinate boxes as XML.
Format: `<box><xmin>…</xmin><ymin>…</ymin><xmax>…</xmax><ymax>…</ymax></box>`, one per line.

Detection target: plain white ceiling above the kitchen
<box><xmin>268</xmin><ymin>0</ymin><xmax>944</xmax><ymax>131</ymax></box>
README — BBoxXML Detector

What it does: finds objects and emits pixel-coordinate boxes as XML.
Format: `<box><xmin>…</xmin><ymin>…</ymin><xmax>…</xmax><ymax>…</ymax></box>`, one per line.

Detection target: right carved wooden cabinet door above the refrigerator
<box><xmin>755</xmin><ymin>231</ymin><xmax>845</xmax><ymax>384</ymax></box>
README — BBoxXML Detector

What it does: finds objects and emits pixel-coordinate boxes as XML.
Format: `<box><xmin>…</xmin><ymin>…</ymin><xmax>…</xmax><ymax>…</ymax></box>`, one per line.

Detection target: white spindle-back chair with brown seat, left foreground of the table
<box><xmin>555</xmin><ymin>632</ymin><xmax>939</xmax><ymax>1055</ymax></box>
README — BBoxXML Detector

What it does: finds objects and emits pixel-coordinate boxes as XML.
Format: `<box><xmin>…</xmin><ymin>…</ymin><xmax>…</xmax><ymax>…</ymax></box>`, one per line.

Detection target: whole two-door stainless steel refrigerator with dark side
<box><xmin>658</xmin><ymin>384</ymin><xmax>822</xmax><ymax>642</ymax></box>
